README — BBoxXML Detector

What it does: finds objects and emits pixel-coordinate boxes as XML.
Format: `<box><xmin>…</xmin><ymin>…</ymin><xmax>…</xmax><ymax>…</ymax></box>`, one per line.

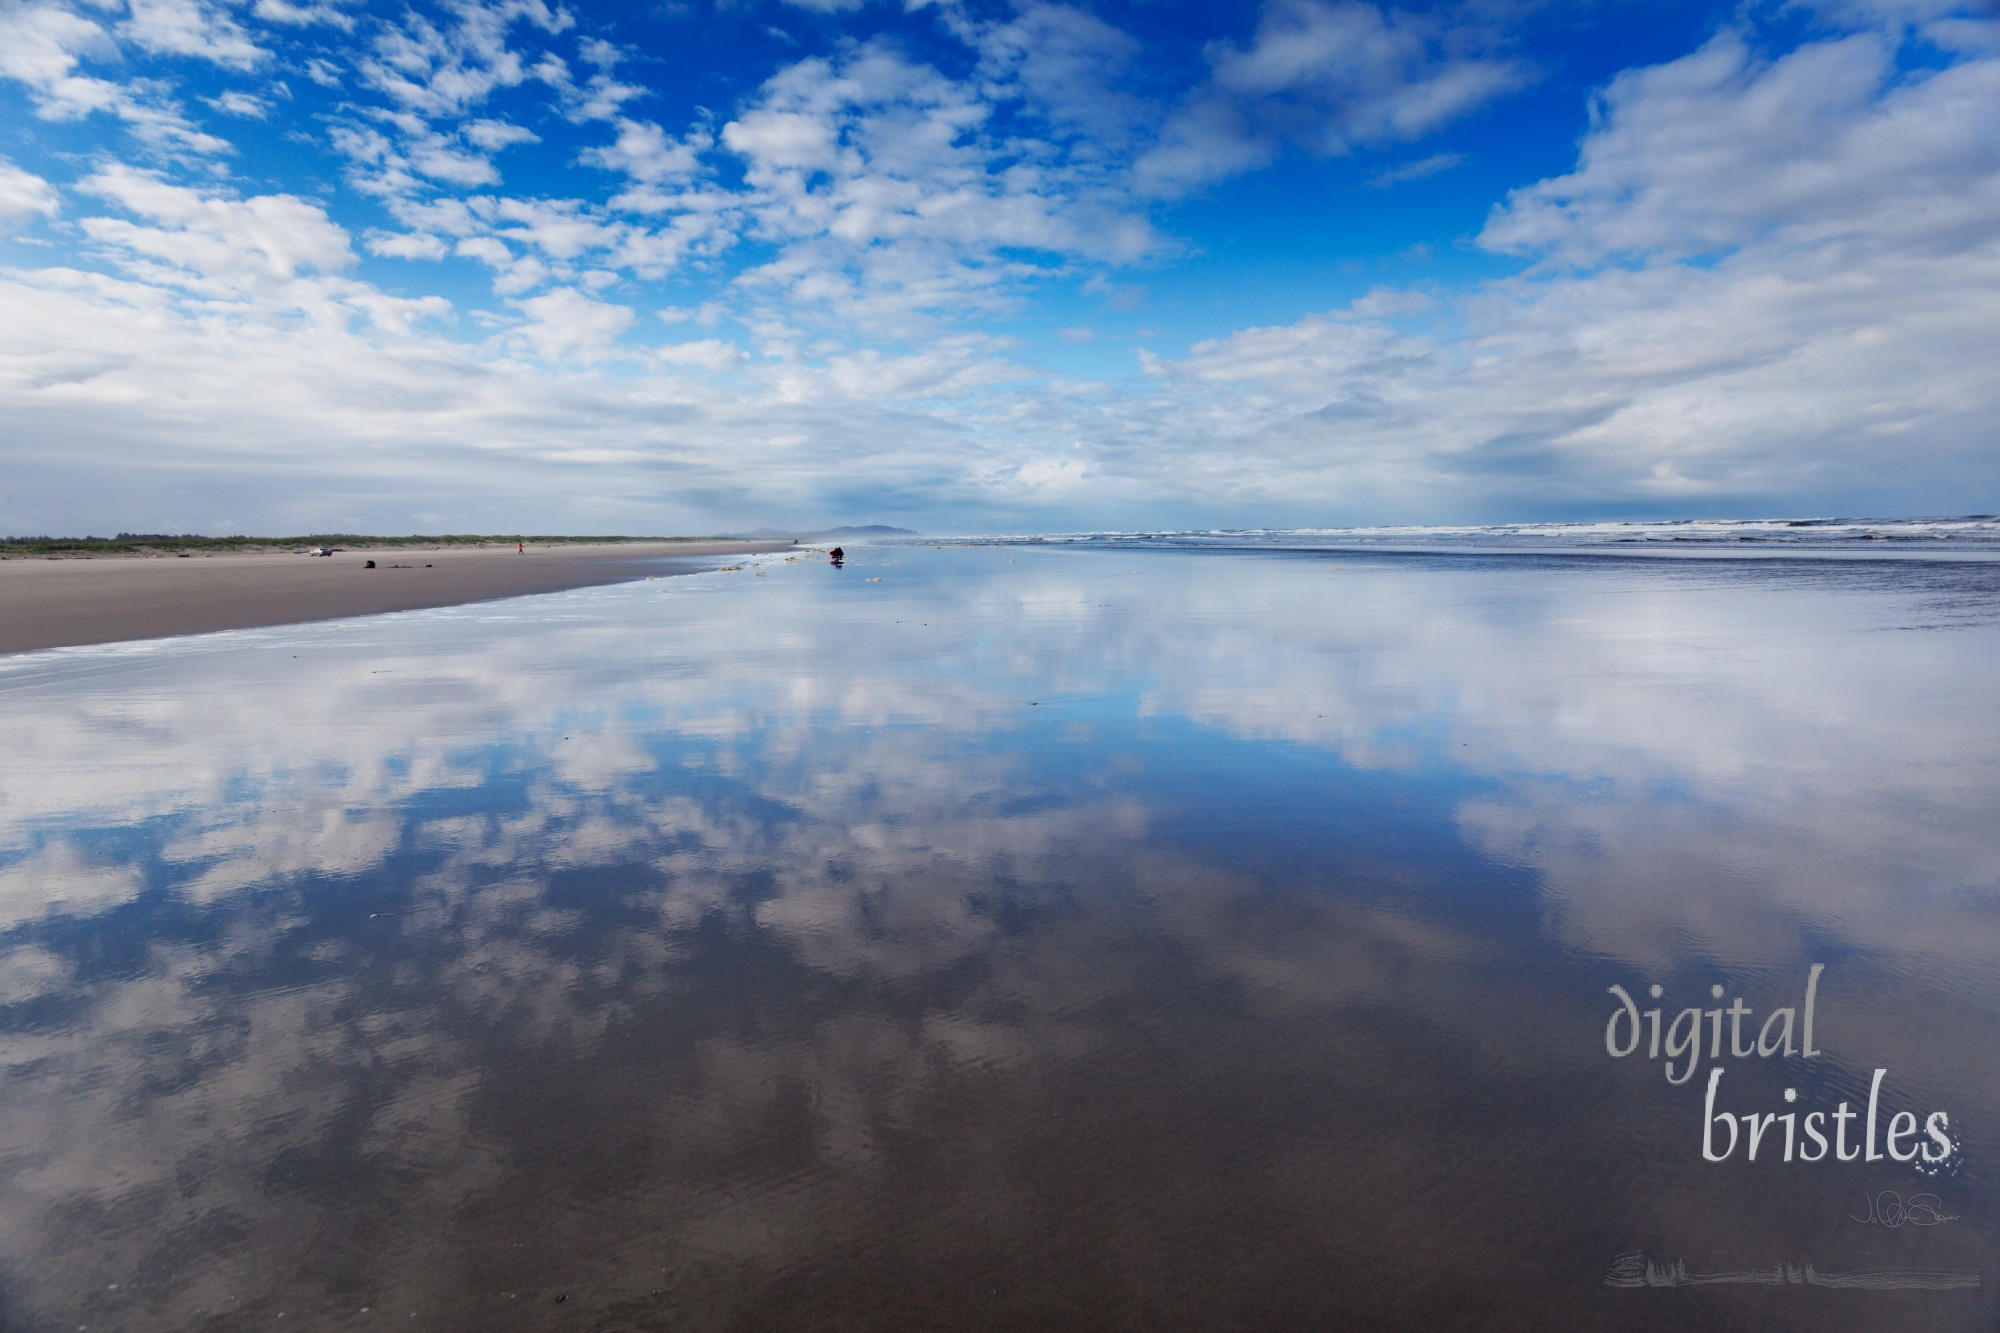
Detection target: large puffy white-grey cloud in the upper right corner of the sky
<box><xmin>1480</xmin><ymin>34</ymin><xmax>2000</xmax><ymax>264</ymax></box>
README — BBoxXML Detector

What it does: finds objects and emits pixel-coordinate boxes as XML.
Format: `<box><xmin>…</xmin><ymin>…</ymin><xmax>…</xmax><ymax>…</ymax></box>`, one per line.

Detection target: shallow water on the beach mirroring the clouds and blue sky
<box><xmin>0</xmin><ymin>546</ymin><xmax>2000</xmax><ymax>1329</ymax></box>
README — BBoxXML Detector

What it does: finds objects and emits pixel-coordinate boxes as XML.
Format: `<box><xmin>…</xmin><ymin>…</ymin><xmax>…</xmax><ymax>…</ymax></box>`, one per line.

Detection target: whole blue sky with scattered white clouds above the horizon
<box><xmin>0</xmin><ymin>0</ymin><xmax>2000</xmax><ymax>532</ymax></box>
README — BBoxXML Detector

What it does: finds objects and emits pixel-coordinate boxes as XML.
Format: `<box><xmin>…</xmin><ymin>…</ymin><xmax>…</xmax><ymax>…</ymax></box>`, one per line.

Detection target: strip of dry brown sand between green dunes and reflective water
<box><xmin>0</xmin><ymin>542</ymin><xmax>792</xmax><ymax>652</ymax></box>
